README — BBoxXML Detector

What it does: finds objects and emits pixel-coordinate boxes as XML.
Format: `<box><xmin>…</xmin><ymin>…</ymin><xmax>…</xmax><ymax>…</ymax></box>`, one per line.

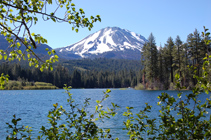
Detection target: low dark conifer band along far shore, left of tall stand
<box><xmin>0</xmin><ymin>63</ymin><xmax>141</xmax><ymax>88</ymax></box>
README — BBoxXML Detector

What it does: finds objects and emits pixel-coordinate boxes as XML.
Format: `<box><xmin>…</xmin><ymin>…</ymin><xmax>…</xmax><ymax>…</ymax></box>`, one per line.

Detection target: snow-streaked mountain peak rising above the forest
<box><xmin>56</xmin><ymin>27</ymin><xmax>147</xmax><ymax>59</ymax></box>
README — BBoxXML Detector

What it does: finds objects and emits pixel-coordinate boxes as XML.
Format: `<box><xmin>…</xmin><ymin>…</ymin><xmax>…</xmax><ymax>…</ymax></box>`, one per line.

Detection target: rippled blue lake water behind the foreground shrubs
<box><xmin>0</xmin><ymin>89</ymin><xmax>211</xmax><ymax>140</ymax></box>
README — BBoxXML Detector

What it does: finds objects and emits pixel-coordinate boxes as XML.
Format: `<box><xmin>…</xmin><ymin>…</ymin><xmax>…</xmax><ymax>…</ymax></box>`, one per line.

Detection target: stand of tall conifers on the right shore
<box><xmin>141</xmin><ymin>29</ymin><xmax>211</xmax><ymax>89</ymax></box>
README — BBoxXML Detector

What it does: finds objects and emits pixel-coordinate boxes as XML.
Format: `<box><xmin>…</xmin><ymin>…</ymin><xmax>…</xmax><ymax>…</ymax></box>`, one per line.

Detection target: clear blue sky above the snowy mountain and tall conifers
<box><xmin>31</xmin><ymin>0</ymin><xmax>211</xmax><ymax>48</ymax></box>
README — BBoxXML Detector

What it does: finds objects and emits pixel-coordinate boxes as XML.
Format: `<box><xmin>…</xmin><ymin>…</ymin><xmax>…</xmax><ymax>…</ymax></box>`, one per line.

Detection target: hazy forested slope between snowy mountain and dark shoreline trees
<box><xmin>59</xmin><ymin>58</ymin><xmax>142</xmax><ymax>73</ymax></box>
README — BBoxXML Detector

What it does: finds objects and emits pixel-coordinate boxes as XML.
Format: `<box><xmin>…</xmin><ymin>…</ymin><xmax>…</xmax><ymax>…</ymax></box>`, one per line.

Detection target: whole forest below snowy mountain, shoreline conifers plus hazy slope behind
<box><xmin>0</xmin><ymin>59</ymin><xmax>141</xmax><ymax>88</ymax></box>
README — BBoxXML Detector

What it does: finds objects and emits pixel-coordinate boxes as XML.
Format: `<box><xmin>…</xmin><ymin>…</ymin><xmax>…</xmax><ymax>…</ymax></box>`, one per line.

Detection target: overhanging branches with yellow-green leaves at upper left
<box><xmin>0</xmin><ymin>0</ymin><xmax>101</xmax><ymax>85</ymax></box>
